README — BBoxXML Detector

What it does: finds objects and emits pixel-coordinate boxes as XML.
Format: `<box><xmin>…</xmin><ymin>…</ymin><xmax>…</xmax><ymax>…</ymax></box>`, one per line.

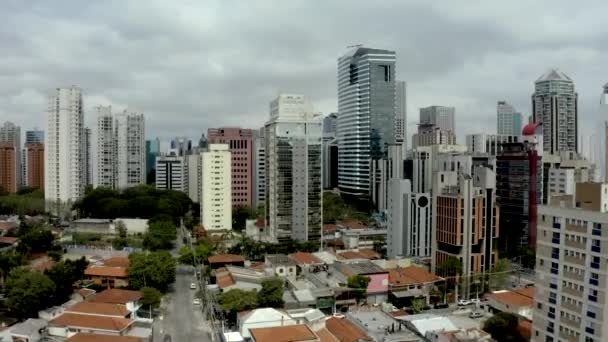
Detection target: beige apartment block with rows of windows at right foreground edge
<box><xmin>532</xmin><ymin>183</ymin><xmax>608</xmax><ymax>342</ymax></box>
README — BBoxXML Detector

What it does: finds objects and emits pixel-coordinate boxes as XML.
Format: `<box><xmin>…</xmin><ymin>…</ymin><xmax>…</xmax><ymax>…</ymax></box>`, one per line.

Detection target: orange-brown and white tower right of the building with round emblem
<box><xmin>431</xmin><ymin>167</ymin><xmax>500</xmax><ymax>298</ymax></box>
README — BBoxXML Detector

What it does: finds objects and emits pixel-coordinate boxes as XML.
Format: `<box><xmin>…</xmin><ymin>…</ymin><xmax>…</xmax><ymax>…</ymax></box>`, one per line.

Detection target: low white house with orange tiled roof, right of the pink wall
<box><xmin>388</xmin><ymin>266</ymin><xmax>443</xmax><ymax>308</ymax></box>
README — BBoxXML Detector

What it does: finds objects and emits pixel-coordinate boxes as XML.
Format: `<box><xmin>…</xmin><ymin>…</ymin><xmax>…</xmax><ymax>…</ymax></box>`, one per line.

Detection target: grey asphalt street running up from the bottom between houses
<box><xmin>154</xmin><ymin>265</ymin><xmax>211</xmax><ymax>342</ymax></box>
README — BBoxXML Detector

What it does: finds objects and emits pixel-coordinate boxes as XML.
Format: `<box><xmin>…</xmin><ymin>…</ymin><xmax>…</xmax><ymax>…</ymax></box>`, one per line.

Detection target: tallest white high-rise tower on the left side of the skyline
<box><xmin>44</xmin><ymin>87</ymin><xmax>86</xmax><ymax>214</ymax></box>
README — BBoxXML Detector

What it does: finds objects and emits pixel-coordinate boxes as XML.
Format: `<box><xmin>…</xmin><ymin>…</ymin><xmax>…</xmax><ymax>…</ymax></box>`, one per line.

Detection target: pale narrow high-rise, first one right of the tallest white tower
<box><xmin>92</xmin><ymin>106</ymin><xmax>116</xmax><ymax>189</ymax></box>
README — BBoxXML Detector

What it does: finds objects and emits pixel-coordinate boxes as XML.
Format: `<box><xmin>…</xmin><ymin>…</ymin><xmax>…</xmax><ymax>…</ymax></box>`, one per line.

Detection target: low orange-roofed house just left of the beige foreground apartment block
<box><xmin>486</xmin><ymin>287</ymin><xmax>534</xmax><ymax>320</ymax></box>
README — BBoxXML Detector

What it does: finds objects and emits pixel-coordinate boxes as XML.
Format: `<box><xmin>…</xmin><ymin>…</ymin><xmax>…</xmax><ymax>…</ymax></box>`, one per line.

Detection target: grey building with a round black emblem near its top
<box><xmin>387</xmin><ymin>179</ymin><xmax>433</xmax><ymax>258</ymax></box>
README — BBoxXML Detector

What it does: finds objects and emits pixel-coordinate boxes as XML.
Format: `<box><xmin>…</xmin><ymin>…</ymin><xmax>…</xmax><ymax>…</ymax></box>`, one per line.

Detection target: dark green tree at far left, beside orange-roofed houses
<box><xmin>6</xmin><ymin>269</ymin><xmax>55</xmax><ymax>318</ymax></box>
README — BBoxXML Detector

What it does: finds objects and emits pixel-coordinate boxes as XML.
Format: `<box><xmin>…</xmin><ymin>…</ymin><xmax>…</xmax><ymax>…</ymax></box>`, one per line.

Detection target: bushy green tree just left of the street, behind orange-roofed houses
<box><xmin>127</xmin><ymin>251</ymin><xmax>175</xmax><ymax>293</ymax></box>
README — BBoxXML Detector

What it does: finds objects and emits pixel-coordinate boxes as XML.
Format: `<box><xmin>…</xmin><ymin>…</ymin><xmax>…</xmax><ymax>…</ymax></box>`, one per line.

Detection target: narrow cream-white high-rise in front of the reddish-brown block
<box><xmin>201</xmin><ymin>144</ymin><xmax>232</xmax><ymax>232</ymax></box>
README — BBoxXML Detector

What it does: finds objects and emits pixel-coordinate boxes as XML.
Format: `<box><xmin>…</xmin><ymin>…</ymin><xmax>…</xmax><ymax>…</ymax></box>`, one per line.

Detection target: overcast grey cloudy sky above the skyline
<box><xmin>0</xmin><ymin>0</ymin><xmax>608</xmax><ymax>148</ymax></box>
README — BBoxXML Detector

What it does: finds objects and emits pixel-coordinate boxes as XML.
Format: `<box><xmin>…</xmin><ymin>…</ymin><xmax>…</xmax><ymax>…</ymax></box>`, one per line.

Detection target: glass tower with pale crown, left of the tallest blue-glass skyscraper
<box><xmin>264</xmin><ymin>94</ymin><xmax>324</xmax><ymax>241</ymax></box>
